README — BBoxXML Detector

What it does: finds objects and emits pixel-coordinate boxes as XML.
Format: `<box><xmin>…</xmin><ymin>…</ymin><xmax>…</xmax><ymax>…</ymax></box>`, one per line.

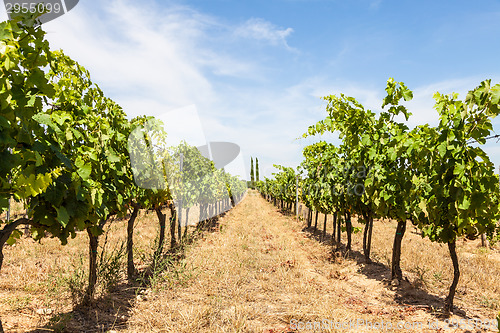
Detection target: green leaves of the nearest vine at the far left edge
<box><xmin>0</xmin><ymin>17</ymin><xmax>67</xmax><ymax>223</ymax></box>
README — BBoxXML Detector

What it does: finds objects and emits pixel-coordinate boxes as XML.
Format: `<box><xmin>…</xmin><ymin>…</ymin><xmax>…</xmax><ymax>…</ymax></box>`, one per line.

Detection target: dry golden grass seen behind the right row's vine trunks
<box><xmin>300</xmin><ymin>209</ymin><xmax>500</xmax><ymax>318</ymax></box>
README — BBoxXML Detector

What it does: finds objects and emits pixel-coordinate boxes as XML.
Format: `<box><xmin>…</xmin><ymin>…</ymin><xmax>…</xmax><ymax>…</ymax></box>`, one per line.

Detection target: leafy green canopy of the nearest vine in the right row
<box><xmin>413</xmin><ymin>81</ymin><xmax>500</xmax><ymax>242</ymax></box>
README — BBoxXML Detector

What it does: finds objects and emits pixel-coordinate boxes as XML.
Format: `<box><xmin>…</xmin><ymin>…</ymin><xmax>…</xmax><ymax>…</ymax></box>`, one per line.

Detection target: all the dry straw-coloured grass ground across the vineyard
<box><xmin>0</xmin><ymin>191</ymin><xmax>500</xmax><ymax>333</ymax></box>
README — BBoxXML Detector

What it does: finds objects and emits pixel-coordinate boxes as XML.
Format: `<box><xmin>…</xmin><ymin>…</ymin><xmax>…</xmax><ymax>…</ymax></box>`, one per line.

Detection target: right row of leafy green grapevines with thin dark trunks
<box><xmin>256</xmin><ymin>79</ymin><xmax>500</xmax><ymax>313</ymax></box>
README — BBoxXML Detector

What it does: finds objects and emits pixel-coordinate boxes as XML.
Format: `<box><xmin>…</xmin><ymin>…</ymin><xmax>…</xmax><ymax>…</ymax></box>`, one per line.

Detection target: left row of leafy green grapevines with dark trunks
<box><xmin>0</xmin><ymin>13</ymin><xmax>246</xmax><ymax>331</ymax></box>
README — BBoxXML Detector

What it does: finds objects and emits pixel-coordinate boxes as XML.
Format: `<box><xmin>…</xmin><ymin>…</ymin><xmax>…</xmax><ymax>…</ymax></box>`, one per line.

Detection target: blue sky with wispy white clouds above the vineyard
<box><xmin>0</xmin><ymin>0</ymin><xmax>500</xmax><ymax>178</ymax></box>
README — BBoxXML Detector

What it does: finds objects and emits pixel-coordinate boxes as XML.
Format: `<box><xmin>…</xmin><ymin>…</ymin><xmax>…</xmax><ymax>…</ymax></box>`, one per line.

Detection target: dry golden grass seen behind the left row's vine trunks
<box><xmin>0</xmin><ymin>206</ymin><xmax>158</xmax><ymax>332</ymax></box>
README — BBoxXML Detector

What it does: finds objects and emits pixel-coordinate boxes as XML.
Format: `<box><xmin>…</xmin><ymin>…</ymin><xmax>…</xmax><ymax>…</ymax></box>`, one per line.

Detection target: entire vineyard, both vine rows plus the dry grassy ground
<box><xmin>0</xmin><ymin>9</ymin><xmax>500</xmax><ymax>332</ymax></box>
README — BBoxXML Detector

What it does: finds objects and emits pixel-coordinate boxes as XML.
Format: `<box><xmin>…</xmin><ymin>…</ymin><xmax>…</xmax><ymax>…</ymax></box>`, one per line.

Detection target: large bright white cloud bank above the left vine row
<box><xmin>36</xmin><ymin>0</ymin><xmax>309</xmax><ymax>179</ymax></box>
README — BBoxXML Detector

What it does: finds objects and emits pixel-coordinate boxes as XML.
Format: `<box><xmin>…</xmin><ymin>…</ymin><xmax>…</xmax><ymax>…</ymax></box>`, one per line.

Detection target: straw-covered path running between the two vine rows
<box><xmin>126</xmin><ymin>192</ymin><xmax>500</xmax><ymax>332</ymax></box>
